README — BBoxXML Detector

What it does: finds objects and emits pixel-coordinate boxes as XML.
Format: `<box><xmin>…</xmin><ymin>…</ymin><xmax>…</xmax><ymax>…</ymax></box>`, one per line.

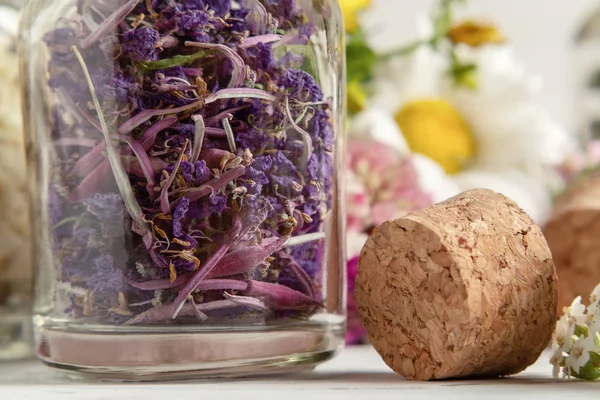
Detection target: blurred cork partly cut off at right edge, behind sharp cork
<box><xmin>544</xmin><ymin>173</ymin><xmax>600</xmax><ymax>311</ymax></box>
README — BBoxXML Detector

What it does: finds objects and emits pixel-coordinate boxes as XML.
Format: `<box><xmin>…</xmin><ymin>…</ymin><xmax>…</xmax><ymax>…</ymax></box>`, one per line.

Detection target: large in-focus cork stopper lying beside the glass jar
<box><xmin>356</xmin><ymin>190</ymin><xmax>557</xmax><ymax>380</ymax></box>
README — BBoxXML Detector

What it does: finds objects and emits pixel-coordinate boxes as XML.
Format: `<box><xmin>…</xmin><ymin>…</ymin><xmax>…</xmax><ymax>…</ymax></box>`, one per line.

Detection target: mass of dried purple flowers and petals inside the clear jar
<box><xmin>44</xmin><ymin>0</ymin><xmax>334</xmax><ymax>324</ymax></box>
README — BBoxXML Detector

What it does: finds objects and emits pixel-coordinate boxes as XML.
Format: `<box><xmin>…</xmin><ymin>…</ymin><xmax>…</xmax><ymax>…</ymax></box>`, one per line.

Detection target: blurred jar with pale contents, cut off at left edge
<box><xmin>0</xmin><ymin>0</ymin><xmax>33</xmax><ymax>360</ymax></box>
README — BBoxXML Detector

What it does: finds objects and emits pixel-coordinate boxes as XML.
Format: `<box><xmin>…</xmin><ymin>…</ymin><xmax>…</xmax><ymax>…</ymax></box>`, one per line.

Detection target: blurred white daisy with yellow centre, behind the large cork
<box><xmin>373</xmin><ymin>30</ymin><xmax>575</xmax><ymax>223</ymax></box>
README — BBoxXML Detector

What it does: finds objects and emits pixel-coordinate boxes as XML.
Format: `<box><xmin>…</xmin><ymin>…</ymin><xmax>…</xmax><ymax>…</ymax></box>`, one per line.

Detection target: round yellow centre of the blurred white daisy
<box><xmin>396</xmin><ymin>99</ymin><xmax>476</xmax><ymax>174</ymax></box>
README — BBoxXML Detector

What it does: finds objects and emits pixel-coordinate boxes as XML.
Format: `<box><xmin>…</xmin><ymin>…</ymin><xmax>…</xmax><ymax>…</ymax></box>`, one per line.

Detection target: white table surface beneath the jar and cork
<box><xmin>0</xmin><ymin>346</ymin><xmax>600</xmax><ymax>400</ymax></box>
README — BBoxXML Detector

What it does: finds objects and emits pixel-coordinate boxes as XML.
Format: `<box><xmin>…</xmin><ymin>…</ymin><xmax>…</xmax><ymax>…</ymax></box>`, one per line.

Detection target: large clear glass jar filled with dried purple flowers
<box><xmin>22</xmin><ymin>0</ymin><xmax>345</xmax><ymax>380</ymax></box>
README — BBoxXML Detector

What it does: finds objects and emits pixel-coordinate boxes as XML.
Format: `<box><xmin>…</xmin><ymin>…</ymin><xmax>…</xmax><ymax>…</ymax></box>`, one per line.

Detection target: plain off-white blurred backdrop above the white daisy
<box><xmin>365</xmin><ymin>0</ymin><xmax>598</xmax><ymax>128</ymax></box>
